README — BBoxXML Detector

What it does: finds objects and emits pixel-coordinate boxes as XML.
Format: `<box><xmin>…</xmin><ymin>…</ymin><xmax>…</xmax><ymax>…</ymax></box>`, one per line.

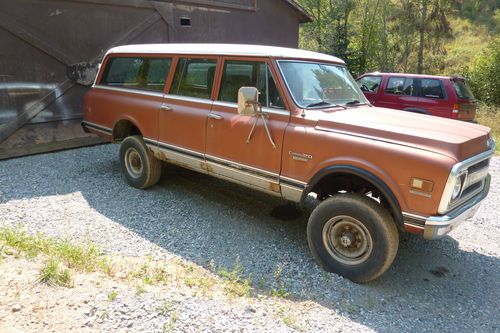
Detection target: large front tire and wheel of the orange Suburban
<box><xmin>307</xmin><ymin>194</ymin><xmax>399</xmax><ymax>283</ymax></box>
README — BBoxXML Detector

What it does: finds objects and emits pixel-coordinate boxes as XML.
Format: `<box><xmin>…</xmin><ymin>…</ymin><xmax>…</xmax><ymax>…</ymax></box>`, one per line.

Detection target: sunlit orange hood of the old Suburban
<box><xmin>316</xmin><ymin>107</ymin><xmax>490</xmax><ymax>161</ymax></box>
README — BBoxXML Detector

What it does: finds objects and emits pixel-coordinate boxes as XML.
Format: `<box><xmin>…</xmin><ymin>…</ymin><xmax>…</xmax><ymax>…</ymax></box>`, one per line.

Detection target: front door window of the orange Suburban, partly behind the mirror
<box><xmin>219</xmin><ymin>60</ymin><xmax>284</xmax><ymax>108</ymax></box>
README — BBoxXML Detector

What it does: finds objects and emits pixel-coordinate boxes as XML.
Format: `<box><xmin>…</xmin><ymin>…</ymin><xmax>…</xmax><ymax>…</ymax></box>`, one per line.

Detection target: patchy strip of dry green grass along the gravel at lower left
<box><xmin>0</xmin><ymin>227</ymin><xmax>251</xmax><ymax>301</ymax></box>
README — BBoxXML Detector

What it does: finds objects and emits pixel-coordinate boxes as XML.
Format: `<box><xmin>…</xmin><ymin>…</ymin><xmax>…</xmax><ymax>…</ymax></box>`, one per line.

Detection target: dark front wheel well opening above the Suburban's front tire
<box><xmin>303</xmin><ymin>170</ymin><xmax>404</xmax><ymax>228</ymax></box>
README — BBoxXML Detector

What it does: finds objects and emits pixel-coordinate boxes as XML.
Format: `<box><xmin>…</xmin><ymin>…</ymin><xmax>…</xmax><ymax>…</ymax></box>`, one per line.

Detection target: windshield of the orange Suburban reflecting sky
<box><xmin>279</xmin><ymin>61</ymin><xmax>368</xmax><ymax>108</ymax></box>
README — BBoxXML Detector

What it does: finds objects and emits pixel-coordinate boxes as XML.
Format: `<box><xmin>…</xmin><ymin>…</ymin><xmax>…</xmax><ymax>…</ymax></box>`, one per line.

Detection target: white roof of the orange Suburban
<box><xmin>106</xmin><ymin>44</ymin><xmax>345</xmax><ymax>64</ymax></box>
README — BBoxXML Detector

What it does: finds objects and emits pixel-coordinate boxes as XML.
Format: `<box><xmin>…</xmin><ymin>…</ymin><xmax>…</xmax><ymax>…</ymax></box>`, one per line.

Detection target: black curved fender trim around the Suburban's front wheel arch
<box><xmin>300</xmin><ymin>165</ymin><xmax>404</xmax><ymax>229</ymax></box>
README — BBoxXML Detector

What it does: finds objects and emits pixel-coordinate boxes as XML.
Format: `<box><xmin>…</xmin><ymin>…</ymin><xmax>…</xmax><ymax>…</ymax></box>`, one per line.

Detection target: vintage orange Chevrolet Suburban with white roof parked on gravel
<box><xmin>82</xmin><ymin>44</ymin><xmax>495</xmax><ymax>282</ymax></box>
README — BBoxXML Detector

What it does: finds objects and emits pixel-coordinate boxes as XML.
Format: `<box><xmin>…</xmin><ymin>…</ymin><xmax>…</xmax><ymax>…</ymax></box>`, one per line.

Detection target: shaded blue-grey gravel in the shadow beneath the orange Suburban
<box><xmin>0</xmin><ymin>148</ymin><xmax>500</xmax><ymax>332</ymax></box>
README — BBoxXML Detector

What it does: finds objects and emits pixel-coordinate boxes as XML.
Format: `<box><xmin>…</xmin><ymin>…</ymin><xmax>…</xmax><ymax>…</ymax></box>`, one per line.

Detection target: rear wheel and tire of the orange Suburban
<box><xmin>120</xmin><ymin>135</ymin><xmax>161</xmax><ymax>189</ymax></box>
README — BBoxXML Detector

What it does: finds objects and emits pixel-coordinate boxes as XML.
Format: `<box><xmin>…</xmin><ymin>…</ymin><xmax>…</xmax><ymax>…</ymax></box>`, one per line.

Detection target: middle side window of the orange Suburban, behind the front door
<box><xmin>170</xmin><ymin>58</ymin><xmax>217</xmax><ymax>98</ymax></box>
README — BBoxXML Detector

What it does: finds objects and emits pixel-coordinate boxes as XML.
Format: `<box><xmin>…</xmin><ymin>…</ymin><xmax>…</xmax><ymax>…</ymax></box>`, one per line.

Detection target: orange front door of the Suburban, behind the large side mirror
<box><xmin>206</xmin><ymin>58</ymin><xmax>290</xmax><ymax>195</ymax></box>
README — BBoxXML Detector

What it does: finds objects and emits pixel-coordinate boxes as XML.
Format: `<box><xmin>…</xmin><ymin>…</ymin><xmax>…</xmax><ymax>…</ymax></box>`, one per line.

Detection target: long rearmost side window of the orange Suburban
<box><xmin>100</xmin><ymin>57</ymin><xmax>172</xmax><ymax>91</ymax></box>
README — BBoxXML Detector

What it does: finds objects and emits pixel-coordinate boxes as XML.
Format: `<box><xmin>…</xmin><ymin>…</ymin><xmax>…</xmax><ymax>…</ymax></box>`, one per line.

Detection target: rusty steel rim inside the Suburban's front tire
<box><xmin>323</xmin><ymin>215</ymin><xmax>373</xmax><ymax>265</ymax></box>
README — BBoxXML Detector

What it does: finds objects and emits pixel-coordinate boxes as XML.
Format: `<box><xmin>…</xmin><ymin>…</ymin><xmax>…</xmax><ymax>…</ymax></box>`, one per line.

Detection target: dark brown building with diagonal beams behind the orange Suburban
<box><xmin>0</xmin><ymin>0</ymin><xmax>311</xmax><ymax>159</ymax></box>
